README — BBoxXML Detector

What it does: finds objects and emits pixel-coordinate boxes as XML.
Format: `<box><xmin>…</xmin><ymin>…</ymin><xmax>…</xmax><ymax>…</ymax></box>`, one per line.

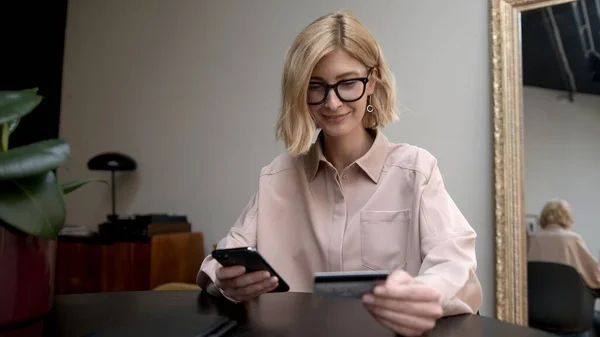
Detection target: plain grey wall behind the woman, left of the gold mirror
<box><xmin>61</xmin><ymin>0</ymin><xmax>494</xmax><ymax>315</ymax></box>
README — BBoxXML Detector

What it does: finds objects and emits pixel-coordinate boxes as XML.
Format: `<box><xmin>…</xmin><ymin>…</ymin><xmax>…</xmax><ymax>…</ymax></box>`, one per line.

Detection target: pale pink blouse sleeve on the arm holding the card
<box><xmin>415</xmin><ymin>161</ymin><xmax>483</xmax><ymax>316</ymax></box>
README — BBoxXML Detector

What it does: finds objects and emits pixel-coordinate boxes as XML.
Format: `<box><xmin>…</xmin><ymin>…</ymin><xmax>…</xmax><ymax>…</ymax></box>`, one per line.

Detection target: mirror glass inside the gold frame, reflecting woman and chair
<box><xmin>521</xmin><ymin>0</ymin><xmax>600</xmax><ymax>336</ymax></box>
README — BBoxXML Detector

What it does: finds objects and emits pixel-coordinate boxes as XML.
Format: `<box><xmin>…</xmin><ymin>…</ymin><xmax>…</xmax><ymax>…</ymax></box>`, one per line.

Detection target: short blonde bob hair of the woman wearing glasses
<box><xmin>275</xmin><ymin>11</ymin><xmax>398</xmax><ymax>155</ymax></box>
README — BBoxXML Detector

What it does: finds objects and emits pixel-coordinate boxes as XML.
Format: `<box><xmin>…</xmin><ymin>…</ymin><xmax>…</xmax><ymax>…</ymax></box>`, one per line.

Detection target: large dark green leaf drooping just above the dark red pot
<box><xmin>0</xmin><ymin>171</ymin><xmax>66</xmax><ymax>239</ymax></box>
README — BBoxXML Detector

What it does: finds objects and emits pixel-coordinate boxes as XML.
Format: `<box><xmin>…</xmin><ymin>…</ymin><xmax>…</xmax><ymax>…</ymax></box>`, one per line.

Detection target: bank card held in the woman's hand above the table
<box><xmin>313</xmin><ymin>270</ymin><xmax>389</xmax><ymax>299</ymax></box>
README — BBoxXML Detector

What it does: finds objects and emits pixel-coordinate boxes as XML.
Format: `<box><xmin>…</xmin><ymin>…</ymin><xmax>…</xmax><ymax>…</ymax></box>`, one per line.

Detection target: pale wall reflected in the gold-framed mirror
<box><xmin>523</xmin><ymin>87</ymin><xmax>600</xmax><ymax>258</ymax></box>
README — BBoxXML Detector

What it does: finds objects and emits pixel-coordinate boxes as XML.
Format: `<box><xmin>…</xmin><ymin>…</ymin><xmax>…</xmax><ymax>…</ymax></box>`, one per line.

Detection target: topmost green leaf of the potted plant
<box><xmin>0</xmin><ymin>88</ymin><xmax>43</xmax><ymax>124</ymax></box>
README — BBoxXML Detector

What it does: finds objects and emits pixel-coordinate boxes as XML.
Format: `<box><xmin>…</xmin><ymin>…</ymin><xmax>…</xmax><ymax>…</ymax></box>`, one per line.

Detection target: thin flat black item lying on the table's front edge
<box><xmin>86</xmin><ymin>312</ymin><xmax>237</xmax><ymax>337</ymax></box>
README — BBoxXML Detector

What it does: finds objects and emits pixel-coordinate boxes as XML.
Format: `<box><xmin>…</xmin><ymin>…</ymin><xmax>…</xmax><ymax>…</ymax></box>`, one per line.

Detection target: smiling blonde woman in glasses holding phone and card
<box><xmin>197</xmin><ymin>12</ymin><xmax>482</xmax><ymax>336</ymax></box>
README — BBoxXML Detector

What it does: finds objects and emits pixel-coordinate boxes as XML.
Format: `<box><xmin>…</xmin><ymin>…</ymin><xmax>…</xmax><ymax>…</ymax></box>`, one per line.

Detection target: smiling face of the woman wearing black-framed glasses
<box><xmin>307</xmin><ymin>50</ymin><xmax>375</xmax><ymax>137</ymax></box>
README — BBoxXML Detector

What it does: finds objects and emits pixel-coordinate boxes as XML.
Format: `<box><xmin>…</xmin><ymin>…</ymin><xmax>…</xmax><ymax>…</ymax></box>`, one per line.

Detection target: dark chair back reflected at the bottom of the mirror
<box><xmin>527</xmin><ymin>262</ymin><xmax>596</xmax><ymax>334</ymax></box>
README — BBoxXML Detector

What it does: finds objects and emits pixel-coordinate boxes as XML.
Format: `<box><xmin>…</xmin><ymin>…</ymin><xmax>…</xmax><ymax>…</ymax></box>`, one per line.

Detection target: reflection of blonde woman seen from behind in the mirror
<box><xmin>527</xmin><ymin>200</ymin><xmax>600</xmax><ymax>290</ymax></box>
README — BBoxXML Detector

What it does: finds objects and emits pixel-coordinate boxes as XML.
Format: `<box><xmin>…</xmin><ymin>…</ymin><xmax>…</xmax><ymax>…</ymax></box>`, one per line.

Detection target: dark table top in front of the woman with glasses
<box><xmin>0</xmin><ymin>291</ymin><xmax>552</xmax><ymax>337</ymax></box>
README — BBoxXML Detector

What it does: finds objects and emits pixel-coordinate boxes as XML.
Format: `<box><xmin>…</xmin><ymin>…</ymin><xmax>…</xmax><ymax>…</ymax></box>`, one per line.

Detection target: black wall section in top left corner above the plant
<box><xmin>0</xmin><ymin>0</ymin><xmax>67</xmax><ymax>147</ymax></box>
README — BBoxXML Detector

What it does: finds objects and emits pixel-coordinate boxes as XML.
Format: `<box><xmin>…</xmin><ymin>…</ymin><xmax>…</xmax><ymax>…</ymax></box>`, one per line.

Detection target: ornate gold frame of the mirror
<box><xmin>490</xmin><ymin>0</ymin><xmax>576</xmax><ymax>326</ymax></box>
